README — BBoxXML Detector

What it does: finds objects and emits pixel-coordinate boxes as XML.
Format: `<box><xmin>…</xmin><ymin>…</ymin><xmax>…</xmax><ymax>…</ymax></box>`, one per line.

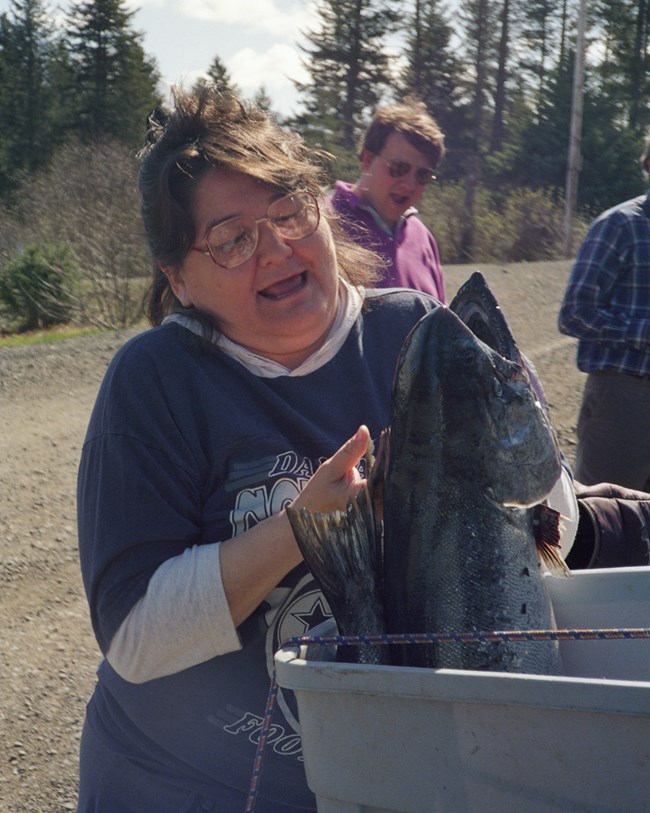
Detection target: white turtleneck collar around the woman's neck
<box><xmin>162</xmin><ymin>279</ymin><xmax>363</xmax><ymax>378</ymax></box>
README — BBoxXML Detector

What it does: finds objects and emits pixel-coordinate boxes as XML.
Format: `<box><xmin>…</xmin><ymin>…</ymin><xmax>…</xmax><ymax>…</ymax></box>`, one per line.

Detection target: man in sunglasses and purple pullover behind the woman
<box><xmin>329</xmin><ymin>101</ymin><xmax>446</xmax><ymax>302</ymax></box>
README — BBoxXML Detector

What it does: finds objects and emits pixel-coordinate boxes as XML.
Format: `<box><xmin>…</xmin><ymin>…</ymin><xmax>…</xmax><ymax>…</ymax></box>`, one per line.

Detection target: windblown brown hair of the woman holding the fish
<box><xmin>139</xmin><ymin>85</ymin><xmax>377</xmax><ymax>324</ymax></box>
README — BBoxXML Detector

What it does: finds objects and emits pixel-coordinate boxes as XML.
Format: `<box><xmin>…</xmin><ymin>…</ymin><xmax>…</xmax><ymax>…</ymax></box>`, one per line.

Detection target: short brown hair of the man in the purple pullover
<box><xmin>359</xmin><ymin>98</ymin><xmax>445</xmax><ymax>169</ymax></box>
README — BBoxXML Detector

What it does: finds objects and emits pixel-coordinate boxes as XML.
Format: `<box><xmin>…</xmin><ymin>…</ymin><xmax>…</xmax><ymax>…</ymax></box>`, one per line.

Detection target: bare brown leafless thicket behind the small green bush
<box><xmin>0</xmin><ymin>140</ymin><xmax>151</xmax><ymax>329</ymax></box>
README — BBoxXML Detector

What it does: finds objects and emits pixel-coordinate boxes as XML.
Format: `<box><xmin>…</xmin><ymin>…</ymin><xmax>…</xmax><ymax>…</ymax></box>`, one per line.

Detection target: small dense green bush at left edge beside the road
<box><xmin>0</xmin><ymin>245</ymin><xmax>73</xmax><ymax>330</ymax></box>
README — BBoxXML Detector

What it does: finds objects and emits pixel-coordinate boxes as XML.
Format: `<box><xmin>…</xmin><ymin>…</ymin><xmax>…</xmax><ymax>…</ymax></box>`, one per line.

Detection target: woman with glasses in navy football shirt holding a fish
<box><xmin>78</xmin><ymin>87</ymin><xmax>437</xmax><ymax>813</ymax></box>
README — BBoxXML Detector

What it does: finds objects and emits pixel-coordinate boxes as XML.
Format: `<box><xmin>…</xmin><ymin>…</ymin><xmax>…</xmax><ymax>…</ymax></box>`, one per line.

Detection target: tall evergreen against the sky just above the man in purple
<box><xmin>292</xmin><ymin>0</ymin><xmax>398</xmax><ymax>148</ymax></box>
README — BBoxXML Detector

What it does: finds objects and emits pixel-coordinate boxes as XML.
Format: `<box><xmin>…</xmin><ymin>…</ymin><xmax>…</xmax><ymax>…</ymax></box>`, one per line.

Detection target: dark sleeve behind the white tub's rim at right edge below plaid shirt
<box><xmin>566</xmin><ymin>481</ymin><xmax>650</xmax><ymax>570</ymax></box>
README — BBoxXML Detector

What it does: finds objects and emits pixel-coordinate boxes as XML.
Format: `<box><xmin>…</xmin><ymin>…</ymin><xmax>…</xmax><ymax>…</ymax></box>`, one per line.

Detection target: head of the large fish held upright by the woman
<box><xmin>384</xmin><ymin>307</ymin><xmax>560</xmax><ymax>506</ymax></box>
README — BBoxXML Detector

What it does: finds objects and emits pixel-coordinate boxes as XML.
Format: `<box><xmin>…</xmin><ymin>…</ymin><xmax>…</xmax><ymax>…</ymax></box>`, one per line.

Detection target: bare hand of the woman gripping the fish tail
<box><xmin>293</xmin><ymin>426</ymin><xmax>370</xmax><ymax>513</ymax></box>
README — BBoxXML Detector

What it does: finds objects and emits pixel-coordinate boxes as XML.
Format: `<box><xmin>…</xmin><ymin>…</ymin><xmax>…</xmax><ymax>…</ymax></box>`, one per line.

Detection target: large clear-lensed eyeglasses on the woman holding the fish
<box><xmin>192</xmin><ymin>192</ymin><xmax>320</xmax><ymax>268</ymax></box>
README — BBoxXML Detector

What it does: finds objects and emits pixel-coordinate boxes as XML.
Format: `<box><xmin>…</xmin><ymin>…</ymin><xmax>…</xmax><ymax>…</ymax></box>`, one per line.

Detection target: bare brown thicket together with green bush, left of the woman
<box><xmin>0</xmin><ymin>141</ymin><xmax>149</xmax><ymax>334</ymax></box>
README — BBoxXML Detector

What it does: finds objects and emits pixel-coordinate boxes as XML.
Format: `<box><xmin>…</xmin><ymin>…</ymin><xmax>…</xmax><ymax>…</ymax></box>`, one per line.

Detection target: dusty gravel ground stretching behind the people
<box><xmin>0</xmin><ymin>262</ymin><xmax>583</xmax><ymax>813</ymax></box>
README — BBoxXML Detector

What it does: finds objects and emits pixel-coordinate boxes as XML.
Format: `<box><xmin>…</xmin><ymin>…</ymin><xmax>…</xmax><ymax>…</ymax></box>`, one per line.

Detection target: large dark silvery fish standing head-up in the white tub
<box><xmin>383</xmin><ymin>308</ymin><xmax>560</xmax><ymax>672</ymax></box>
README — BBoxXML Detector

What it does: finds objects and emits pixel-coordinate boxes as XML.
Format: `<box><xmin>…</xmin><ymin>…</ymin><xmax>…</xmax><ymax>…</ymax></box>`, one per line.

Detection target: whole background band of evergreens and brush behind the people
<box><xmin>0</xmin><ymin>0</ymin><xmax>650</xmax><ymax>335</ymax></box>
